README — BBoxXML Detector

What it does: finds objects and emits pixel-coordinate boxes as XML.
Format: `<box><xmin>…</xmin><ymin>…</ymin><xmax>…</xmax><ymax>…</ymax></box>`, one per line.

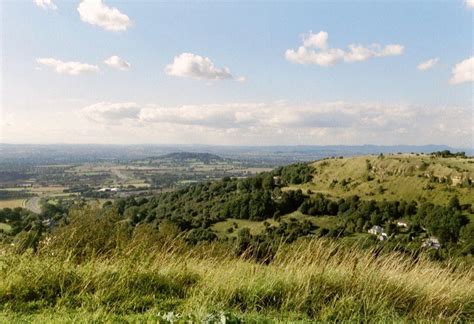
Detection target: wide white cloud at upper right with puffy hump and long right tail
<box><xmin>285</xmin><ymin>31</ymin><xmax>404</xmax><ymax>66</ymax></box>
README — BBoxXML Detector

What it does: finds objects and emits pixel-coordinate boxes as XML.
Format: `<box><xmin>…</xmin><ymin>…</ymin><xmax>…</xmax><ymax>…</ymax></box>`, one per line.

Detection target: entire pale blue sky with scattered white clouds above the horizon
<box><xmin>0</xmin><ymin>0</ymin><xmax>474</xmax><ymax>148</ymax></box>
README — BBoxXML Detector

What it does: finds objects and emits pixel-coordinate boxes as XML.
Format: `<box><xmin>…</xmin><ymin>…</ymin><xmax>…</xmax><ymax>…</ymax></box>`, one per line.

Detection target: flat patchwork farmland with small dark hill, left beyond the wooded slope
<box><xmin>0</xmin><ymin>153</ymin><xmax>270</xmax><ymax>212</ymax></box>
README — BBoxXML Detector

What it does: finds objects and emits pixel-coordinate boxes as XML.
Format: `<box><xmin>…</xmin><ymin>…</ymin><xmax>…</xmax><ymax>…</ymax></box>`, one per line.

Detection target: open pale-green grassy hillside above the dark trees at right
<box><xmin>290</xmin><ymin>154</ymin><xmax>474</xmax><ymax>205</ymax></box>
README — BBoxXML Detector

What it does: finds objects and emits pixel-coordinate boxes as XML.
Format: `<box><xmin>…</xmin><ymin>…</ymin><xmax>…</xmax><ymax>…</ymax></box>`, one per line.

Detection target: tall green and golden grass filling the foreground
<box><xmin>0</xmin><ymin>230</ymin><xmax>474</xmax><ymax>323</ymax></box>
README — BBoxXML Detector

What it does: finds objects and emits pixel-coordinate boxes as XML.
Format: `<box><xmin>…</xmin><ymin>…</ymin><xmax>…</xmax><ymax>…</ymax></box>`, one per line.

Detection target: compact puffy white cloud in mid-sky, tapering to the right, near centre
<box><xmin>165</xmin><ymin>53</ymin><xmax>245</xmax><ymax>82</ymax></box>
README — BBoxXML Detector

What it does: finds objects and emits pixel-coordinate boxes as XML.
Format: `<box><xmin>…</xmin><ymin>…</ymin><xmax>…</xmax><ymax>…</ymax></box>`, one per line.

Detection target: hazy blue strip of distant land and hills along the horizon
<box><xmin>0</xmin><ymin>143</ymin><xmax>474</xmax><ymax>166</ymax></box>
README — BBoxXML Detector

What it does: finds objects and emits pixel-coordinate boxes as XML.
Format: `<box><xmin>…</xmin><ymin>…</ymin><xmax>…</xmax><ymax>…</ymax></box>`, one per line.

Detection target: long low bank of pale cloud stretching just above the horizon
<box><xmin>81</xmin><ymin>102</ymin><xmax>474</xmax><ymax>145</ymax></box>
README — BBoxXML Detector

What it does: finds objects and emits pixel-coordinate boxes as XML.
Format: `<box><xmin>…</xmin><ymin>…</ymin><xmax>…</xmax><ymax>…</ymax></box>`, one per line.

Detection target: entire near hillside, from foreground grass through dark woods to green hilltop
<box><xmin>0</xmin><ymin>155</ymin><xmax>474</xmax><ymax>323</ymax></box>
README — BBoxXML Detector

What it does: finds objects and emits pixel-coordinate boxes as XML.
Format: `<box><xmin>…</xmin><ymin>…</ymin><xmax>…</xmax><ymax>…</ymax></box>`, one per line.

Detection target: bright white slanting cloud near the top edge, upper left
<box><xmin>77</xmin><ymin>0</ymin><xmax>132</xmax><ymax>32</ymax></box>
